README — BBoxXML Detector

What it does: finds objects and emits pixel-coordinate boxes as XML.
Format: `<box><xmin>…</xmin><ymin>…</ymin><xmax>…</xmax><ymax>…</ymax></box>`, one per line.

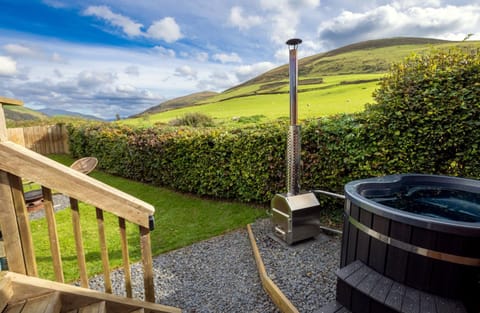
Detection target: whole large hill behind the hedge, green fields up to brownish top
<box><xmin>122</xmin><ymin>38</ymin><xmax>480</xmax><ymax>126</ymax></box>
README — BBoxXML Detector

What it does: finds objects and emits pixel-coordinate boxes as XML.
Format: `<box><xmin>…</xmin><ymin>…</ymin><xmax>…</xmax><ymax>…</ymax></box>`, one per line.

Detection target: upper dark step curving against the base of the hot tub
<box><xmin>337</xmin><ymin>261</ymin><xmax>467</xmax><ymax>313</ymax></box>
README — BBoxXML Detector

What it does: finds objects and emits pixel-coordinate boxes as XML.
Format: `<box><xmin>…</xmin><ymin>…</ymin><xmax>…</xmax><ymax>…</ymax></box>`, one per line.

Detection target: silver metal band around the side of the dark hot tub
<box><xmin>348</xmin><ymin>216</ymin><xmax>480</xmax><ymax>266</ymax></box>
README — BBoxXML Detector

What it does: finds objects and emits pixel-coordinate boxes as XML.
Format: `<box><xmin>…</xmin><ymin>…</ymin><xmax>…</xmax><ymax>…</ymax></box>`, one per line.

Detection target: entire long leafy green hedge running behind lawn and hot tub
<box><xmin>69</xmin><ymin>50</ymin><xmax>480</xmax><ymax>203</ymax></box>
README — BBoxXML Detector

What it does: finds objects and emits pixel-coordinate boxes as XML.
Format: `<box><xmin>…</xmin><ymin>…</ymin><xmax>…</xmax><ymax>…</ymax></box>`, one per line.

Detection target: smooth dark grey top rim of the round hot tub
<box><xmin>345</xmin><ymin>173</ymin><xmax>480</xmax><ymax>237</ymax></box>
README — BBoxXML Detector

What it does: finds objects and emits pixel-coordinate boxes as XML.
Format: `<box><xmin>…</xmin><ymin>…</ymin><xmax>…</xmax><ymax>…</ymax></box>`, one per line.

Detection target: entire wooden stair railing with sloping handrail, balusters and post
<box><xmin>0</xmin><ymin>98</ymin><xmax>155</xmax><ymax>302</ymax></box>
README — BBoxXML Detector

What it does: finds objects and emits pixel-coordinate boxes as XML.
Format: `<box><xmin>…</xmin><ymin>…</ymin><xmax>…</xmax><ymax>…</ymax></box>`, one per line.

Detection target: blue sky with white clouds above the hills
<box><xmin>0</xmin><ymin>0</ymin><xmax>480</xmax><ymax>118</ymax></box>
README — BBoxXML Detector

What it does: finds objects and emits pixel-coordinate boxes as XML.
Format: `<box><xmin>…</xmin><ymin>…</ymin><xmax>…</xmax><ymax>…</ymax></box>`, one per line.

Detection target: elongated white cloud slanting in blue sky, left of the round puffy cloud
<box><xmin>84</xmin><ymin>5</ymin><xmax>143</xmax><ymax>37</ymax></box>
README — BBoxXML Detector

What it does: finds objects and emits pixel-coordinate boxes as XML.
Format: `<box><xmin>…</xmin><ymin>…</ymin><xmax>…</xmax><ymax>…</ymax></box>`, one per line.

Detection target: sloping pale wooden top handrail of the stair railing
<box><xmin>0</xmin><ymin>141</ymin><xmax>155</xmax><ymax>228</ymax></box>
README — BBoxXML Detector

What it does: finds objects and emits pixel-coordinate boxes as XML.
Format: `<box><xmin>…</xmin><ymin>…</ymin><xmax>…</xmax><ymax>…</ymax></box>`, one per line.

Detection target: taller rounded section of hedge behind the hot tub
<box><xmin>363</xmin><ymin>50</ymin><xmax>480</xmax><ymax>177</ymax></box>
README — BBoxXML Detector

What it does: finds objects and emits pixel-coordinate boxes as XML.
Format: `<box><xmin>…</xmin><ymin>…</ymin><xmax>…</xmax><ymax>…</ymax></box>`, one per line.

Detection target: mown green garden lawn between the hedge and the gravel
<box><xmin>31</xmin><ymin>155</ymin><xmax>266</xmax><ymax>281</ymax></box>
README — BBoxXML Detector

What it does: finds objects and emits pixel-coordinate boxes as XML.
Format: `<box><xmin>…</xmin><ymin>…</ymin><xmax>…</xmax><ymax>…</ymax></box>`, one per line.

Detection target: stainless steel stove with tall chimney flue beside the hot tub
<box><xmin>271</xmin><ymin>38</ymin><xmax>320</xmax><ymax>245</ymax></box>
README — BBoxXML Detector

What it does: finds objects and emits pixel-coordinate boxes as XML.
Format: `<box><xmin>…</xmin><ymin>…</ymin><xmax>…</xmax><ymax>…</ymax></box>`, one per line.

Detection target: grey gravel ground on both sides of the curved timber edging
<box><xmin>90</xmin><ymin>219</ymin><xmax>340</xmax><ymax>313</ymax></box>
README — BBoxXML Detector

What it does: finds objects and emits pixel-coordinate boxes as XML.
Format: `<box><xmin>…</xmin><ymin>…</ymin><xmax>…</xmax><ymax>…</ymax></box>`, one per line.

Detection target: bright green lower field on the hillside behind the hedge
<box><xmin>121</xmin><ymin>74</ymin><xmax>384</xmax><ymax>127</ymax></box>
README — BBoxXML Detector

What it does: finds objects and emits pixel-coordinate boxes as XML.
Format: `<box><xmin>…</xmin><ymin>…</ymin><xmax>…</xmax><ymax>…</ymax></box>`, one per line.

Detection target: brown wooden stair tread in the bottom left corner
<box><xmin>3</xmin><ymin>292</ymin><xmax>62</xmax><ymax>313</ymax></box>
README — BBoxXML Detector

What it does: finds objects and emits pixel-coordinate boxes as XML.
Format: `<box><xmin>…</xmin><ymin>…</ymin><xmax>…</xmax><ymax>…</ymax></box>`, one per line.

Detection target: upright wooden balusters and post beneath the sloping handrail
<box><xmin>0</xmin><ymin>170</ymin><xmax>155</xmax><ymax>302</ymax></box>
